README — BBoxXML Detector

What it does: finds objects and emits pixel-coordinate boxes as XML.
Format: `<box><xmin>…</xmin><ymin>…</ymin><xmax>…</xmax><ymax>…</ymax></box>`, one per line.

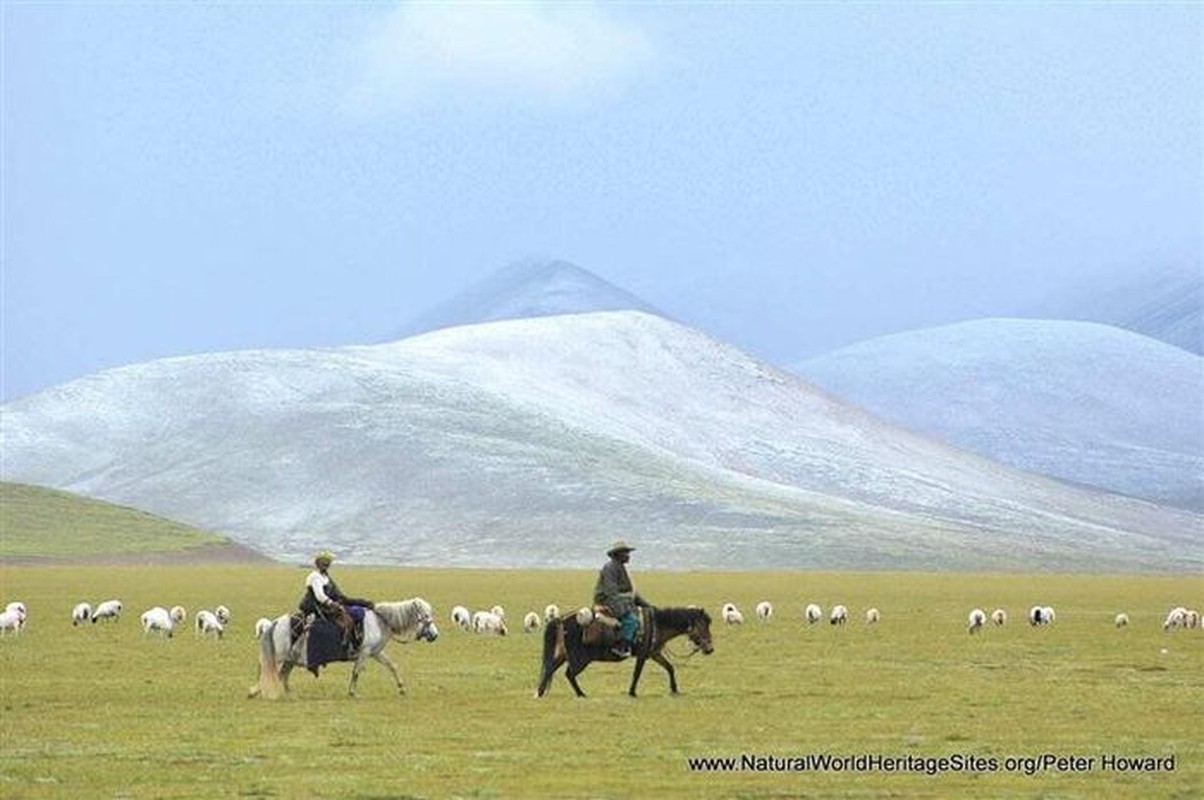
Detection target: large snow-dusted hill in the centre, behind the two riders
<box><xmin>0</xmin><ymin>312</ymin><xmax>1204</xmax><ymax>570</ymax></box>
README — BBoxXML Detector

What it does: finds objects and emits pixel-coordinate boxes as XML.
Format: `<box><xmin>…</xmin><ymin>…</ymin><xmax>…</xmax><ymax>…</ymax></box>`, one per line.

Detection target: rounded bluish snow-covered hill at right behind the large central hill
<box><xmin>793</xmin><ymin>319</ymin><xmax>1204</xmax><ymax>511</ymax></box>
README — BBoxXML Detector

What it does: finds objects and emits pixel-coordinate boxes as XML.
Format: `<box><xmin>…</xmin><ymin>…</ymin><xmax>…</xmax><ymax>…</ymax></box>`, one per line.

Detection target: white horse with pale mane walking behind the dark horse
<box><xmin>249</xmin><ymin>598</ymin><xmax>439</xmax><ymax>698</ymax></box>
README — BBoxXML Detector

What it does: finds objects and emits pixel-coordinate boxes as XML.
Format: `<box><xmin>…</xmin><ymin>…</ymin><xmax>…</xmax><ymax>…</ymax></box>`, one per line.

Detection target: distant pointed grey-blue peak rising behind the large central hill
<box><xmin>388</xmin><ymin>260</ymin><xmax>667</xmax><ymax>341</ymax></box>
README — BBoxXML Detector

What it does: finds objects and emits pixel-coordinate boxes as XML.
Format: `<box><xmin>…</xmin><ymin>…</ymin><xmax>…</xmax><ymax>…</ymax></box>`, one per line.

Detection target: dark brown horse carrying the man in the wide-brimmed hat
<box><xmin>536</xmin><ymin>606</ymin><xmax>715</xmax><ymax>698</ymax></box>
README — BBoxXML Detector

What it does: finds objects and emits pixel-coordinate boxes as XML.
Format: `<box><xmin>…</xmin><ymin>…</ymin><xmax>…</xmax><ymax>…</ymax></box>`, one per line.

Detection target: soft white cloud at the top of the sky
<box><xmin>352</xmin><ymin>2</ymin><xmax>654</xmax><ymax>112</ymax></box>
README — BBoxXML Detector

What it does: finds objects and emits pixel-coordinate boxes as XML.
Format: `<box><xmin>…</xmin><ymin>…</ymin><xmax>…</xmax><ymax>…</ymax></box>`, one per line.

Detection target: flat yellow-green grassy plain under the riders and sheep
<box><xmin>0</xmin><ymin>563</ymin><xmax>1204</xmax><ymax>800</ymax></box>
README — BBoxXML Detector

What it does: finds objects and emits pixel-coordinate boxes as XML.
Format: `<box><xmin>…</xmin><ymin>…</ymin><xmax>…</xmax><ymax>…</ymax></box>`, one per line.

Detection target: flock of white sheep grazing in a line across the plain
<box><xmin>0</xmin><ymin>600</ymin><xmax>1202</xmax><ymax>639</ymax></box>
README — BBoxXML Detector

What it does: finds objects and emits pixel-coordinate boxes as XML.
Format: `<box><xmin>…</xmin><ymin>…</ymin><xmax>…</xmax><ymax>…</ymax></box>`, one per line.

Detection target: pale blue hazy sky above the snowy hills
<box><xmin>0</xmin><ymin>0</ymin><xmax>1204</xmax><ymax>401</ymax></box>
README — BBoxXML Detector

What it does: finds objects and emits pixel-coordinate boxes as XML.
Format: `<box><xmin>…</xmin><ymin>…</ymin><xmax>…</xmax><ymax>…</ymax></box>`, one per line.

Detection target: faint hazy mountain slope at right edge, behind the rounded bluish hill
<box><xmin>1020</xmin><ymin>266</ymin><xmax>1204</xmax><ymax>355</ymax></box>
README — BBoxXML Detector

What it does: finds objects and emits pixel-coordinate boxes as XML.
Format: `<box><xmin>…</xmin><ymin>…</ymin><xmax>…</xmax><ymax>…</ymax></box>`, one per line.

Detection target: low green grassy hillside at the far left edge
<box><xmin>0</xmin><ymin>482</ymin><xmax>226</xmax><ymax>559</ymax></box>
